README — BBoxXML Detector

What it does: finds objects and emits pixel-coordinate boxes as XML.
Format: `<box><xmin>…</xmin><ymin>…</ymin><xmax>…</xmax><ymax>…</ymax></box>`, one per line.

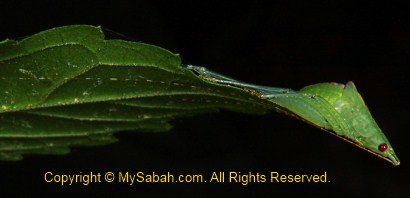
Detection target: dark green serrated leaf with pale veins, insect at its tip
<box><xmin>0</xmin><ymin>25</ymin><xmax>266</xmax><ymax>160</ymax></box>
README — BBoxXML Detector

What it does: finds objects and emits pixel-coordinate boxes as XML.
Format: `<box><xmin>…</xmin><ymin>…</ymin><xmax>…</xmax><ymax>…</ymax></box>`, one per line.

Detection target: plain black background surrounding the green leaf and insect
<box><xmin>0</xmin><ymin>0</ymin><xmax>410</xmax><ymax>197</ymax></box>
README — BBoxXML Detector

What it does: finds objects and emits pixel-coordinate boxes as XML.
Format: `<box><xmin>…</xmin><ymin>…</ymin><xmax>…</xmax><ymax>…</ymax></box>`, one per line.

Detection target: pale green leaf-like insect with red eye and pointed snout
<box><xmin>187</xmin><ymin>65</ymin><xmax>400</xmax><ymax>166</ymax></box>
